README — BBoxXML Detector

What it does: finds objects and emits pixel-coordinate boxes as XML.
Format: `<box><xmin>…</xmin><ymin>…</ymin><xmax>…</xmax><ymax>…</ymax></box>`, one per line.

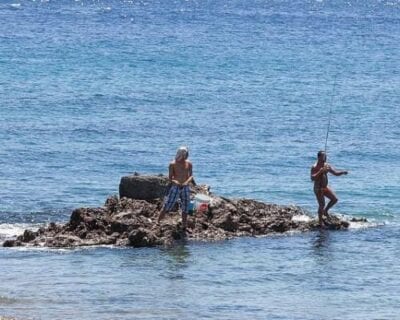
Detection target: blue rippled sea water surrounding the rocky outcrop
<box><xmin>0</xmin><ymin>0</ymin><xmax>400</xmax><ymax>320</ymax></box>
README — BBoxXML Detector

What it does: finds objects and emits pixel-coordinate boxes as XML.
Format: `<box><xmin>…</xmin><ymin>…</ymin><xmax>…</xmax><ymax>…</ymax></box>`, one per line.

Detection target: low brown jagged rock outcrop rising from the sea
<box><xmin>3</xmin><ymin>176</ymin><xmax>358</xmax><ymax>247</ymax></box>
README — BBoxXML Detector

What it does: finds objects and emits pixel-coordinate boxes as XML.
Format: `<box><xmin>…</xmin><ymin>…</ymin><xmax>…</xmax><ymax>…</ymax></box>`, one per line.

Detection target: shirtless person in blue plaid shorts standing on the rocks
<box><xmin>158</xmin><ymin>147</ymin><xmax>193</xmax><ymax>230</ymax></box>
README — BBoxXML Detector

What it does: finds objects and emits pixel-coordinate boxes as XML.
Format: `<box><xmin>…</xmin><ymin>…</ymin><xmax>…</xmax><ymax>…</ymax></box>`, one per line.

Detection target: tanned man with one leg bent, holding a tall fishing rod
<box><xmin>311</xmin><ymin>151</ymin><xmax>347</xmax><ymax>227</ymax></box>
